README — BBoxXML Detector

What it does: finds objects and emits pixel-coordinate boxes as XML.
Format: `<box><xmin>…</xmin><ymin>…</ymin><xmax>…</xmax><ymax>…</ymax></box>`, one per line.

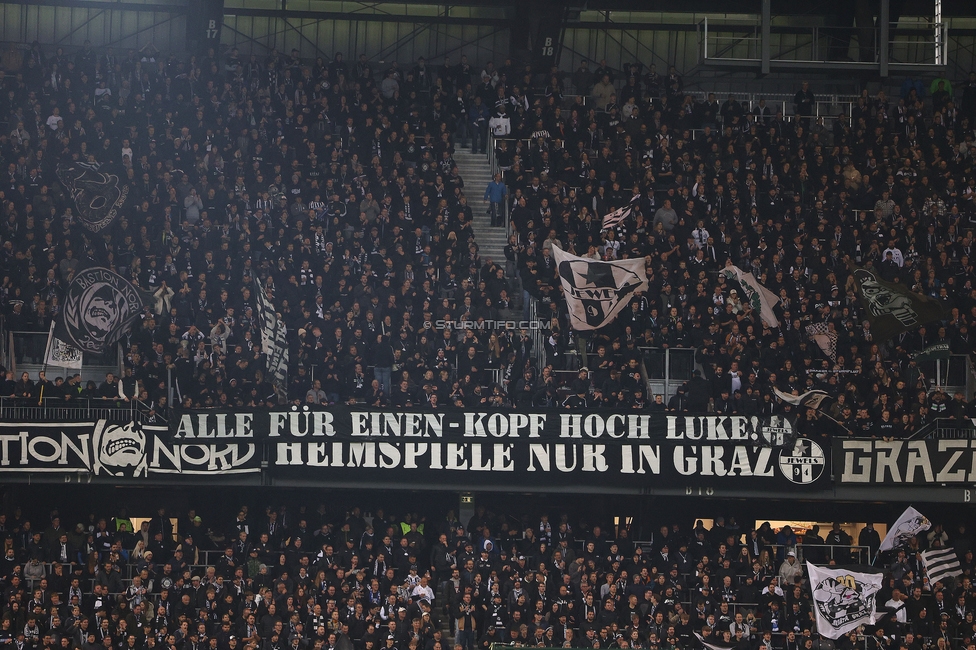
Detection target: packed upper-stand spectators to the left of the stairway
<box><xmin>0</xmin><ymin>43</ymin><xmax>540</xmax><ymax>408</ymax></box>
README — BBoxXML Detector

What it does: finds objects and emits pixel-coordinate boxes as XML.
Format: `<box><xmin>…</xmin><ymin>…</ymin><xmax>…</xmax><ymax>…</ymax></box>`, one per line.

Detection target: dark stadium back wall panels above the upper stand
<box><xmin>0</xmin><ymin>0</ymin><xmax>976</xmax><ymax>83</ymax></box>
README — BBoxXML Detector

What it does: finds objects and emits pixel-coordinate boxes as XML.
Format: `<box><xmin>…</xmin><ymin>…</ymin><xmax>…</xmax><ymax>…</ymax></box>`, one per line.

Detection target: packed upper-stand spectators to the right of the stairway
<box><xmin>491</xmin><ymin>62</ymin><xmax>976</xmax><ymax>426</ymax></box>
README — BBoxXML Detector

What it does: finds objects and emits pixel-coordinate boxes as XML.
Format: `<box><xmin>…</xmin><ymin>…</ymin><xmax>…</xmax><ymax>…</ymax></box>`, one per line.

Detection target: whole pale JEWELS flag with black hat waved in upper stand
<box><xmin>552</xmin><ymin>245</ymin><xmax>647</xmax><ymax>330</ymax></box>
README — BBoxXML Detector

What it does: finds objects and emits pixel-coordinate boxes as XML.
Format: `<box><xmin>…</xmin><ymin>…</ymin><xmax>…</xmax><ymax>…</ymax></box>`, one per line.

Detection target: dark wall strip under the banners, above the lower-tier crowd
<box><xmin>0</xmin><ymin>485</ymin><xmax>974</xmax><ymax>540</ymax></box>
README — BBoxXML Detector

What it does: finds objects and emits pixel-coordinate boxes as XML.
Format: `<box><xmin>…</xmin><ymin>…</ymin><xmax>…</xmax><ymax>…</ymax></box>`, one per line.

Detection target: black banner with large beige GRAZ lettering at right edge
<box><xmin>833</xmin><ymin>439</ymin><xmax>976</xmax><ymax>487</ymax></box>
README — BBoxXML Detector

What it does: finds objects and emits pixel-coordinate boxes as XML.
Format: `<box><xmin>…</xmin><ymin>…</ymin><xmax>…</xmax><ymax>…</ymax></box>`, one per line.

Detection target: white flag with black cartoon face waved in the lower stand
<box><xmin>807</xmin><ymin>562</ymin><xmax>884</xmax><ymax>639</ymax></box>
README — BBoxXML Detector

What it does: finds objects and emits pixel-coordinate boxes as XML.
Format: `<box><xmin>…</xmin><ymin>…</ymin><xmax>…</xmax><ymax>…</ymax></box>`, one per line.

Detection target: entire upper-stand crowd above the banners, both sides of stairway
<box><xmin>0</xmin><ymin>44</ymin><xmax>976</xmax><ymax>436</ymax></box>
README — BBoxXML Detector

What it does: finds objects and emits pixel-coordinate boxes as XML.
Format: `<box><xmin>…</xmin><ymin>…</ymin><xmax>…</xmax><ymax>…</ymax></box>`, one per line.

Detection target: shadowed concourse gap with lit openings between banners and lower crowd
<box><xmin>0</xmin><ymin>484</ymin><xmax>973</xmax><ymax>536</ymax></box>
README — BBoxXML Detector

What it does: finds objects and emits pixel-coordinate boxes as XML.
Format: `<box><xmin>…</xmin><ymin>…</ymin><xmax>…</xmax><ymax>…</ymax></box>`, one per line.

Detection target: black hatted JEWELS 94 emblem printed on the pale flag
<box><xmin>559</xmin><ymin>260</ymin><xmax>646</xmax><ymax>329</ymax></box>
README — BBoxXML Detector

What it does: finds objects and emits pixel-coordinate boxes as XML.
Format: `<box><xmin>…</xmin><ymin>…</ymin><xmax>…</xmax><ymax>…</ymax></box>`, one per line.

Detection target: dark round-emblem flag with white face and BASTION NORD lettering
<box><xmin>54</xmin><ymin>267</ymin><xmax>153</xmax><ymax>354</ymax></box>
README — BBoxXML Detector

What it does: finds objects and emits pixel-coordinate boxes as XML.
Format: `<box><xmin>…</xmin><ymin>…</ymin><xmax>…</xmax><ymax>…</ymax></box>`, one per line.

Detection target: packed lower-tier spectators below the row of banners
<box><xmin>0</xmin><ymin>505</ymin><xmax>976</xmax><ymax>650</ymax></box>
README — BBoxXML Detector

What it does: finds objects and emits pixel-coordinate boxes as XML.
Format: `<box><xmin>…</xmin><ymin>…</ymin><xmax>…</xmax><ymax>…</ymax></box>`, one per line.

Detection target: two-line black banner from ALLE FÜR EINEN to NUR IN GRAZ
<box><xmin>170</xmin><ymin>407</ymin><xmax>830</xmax><ymax>489</ymax></box>
